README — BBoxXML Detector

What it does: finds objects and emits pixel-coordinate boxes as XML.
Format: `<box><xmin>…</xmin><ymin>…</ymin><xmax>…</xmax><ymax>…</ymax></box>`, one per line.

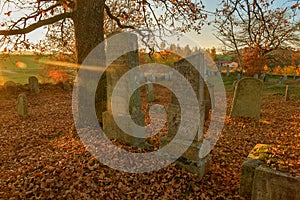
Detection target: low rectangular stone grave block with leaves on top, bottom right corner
<box><xmin>240</xmin><ymin>144</ymin><xmax>300</xmax><ymax>200</ymax></box>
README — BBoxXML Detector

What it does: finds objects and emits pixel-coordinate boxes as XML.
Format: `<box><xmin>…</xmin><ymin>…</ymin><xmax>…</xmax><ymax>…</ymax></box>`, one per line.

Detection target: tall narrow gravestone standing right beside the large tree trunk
<box><xmin>101</xmin><ymin>33</ymin><xmax>145</xmax><ymax>147</ymax></box>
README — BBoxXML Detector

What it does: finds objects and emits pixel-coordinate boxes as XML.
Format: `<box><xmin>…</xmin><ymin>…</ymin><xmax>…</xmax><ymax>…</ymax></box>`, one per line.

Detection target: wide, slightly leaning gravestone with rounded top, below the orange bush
<box><xmin>230</xmin><ymin>78</ymin><xmax>263</xmax><ymax>120</ymax></box>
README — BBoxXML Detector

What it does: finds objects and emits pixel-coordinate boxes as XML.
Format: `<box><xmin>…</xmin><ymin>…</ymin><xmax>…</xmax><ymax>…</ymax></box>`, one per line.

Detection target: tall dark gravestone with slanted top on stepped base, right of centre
<box><xmin>161</xmin><ymin>54</ymin><xmax>209</xmax><ymax>177</ymax></box>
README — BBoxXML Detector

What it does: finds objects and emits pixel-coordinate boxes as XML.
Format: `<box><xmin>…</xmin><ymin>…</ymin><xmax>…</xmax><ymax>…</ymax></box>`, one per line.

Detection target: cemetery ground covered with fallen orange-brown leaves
<box><xmin>0</xmin><ymin>74</ymin><xmax>300</xmax><ymax>200</ymax></box>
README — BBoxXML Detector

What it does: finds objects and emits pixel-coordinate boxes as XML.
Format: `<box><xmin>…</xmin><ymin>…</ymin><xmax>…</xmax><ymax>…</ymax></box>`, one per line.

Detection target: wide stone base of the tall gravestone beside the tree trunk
<box><xmin>102</xmin><ymin>111</ymin><xmax>148</xmax><ymax>148</ymax></box>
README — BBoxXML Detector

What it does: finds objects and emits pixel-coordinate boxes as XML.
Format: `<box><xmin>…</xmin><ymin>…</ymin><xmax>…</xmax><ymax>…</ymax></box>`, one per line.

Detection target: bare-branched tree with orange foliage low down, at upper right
<box><xmin>215</xmin><ymin>0</ymin><xmax>300</xmax><ymax>72</ymax></box>
